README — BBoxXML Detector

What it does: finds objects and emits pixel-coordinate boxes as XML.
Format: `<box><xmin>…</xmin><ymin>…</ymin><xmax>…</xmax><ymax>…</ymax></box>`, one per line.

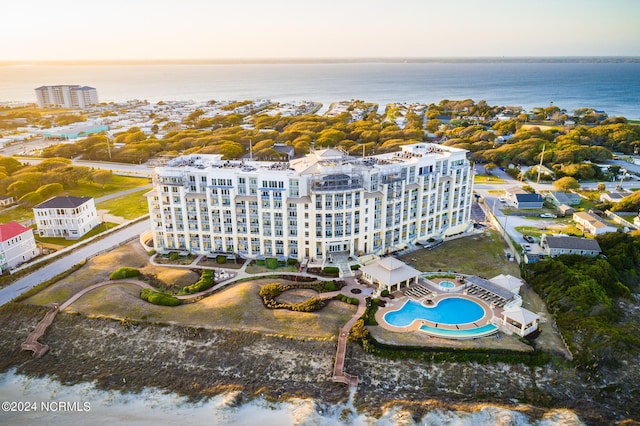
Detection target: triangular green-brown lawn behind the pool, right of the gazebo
<box><xmin>400</xmin><ymin>230</ymin><xmax>520</xmax><ymax>278</ymax></box>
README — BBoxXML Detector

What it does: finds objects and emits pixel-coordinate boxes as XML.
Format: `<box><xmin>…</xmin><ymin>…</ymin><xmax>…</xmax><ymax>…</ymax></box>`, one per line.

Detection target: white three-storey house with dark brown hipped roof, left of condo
<box><xmin>33</xmin><ymin>196</ymin><xmax>100</xmax><ymax>240</ymax></box>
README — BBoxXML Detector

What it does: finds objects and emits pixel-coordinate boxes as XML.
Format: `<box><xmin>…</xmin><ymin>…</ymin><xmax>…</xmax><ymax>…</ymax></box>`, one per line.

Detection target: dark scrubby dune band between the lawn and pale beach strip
<box><xmin>0</xmin><ymin>305</ymin><xmax>632</xmax><ymax>423</ymax></box>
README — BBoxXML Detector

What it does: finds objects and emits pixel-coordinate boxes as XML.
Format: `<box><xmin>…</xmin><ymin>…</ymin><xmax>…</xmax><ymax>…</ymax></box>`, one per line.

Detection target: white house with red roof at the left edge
<box><xmin>0</xmin><ymin>222</ymin><xmax>38</xmax><ymax>272</ymax></box>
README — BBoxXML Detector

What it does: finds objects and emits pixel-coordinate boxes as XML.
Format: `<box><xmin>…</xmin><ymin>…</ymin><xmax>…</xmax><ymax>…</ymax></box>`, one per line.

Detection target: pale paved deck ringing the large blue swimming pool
<box><xmin>376</xmin><ymin>278</ymin><xmax>502</xmax><ymax>338</ymax></box>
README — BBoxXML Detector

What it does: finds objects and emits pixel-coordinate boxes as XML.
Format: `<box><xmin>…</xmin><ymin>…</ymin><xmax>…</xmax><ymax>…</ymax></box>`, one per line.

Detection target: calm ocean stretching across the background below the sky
<box><xmin>0</xmin><ymin>61</ymin><xmax>640</xmax><ymax>119</ymax></box>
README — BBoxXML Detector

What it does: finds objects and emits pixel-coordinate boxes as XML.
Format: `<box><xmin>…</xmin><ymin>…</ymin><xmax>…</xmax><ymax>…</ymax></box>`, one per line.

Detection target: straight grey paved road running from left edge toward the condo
<box><xmin>0</xmin><ymin>220</ymin><xmax>149</xmax><ymax>306</ymax></box>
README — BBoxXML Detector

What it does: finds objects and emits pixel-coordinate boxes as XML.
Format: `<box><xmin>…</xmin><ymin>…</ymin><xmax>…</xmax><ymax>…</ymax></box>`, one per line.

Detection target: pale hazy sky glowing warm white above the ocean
<box><xmin>0</xmin><ymin>0</ymin><xmax>640</xmax><ymax>61</ymax></box>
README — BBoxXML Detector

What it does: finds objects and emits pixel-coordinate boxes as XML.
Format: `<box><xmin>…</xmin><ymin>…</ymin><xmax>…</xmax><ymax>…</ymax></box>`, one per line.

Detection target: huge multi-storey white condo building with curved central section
<box><xmin>147</xmin><ymin>143</ymin><xmax>473</xmax><ymax>260</ymax></box>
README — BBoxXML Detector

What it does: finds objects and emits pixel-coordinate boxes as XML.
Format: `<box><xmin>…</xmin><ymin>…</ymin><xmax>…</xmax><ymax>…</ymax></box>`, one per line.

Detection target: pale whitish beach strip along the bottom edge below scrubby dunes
<box><xmin>0</xmin><ymin>371</ymin><xmax>583</xmax><ymax>426</ymax></box>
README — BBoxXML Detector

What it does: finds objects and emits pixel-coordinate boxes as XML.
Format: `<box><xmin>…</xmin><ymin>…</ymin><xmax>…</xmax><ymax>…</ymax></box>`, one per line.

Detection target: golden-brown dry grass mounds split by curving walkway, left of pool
<box><xmin>25</xmin><ymin>242</ymin><xmax>356</xmax><ymax>338</ymax></box>
